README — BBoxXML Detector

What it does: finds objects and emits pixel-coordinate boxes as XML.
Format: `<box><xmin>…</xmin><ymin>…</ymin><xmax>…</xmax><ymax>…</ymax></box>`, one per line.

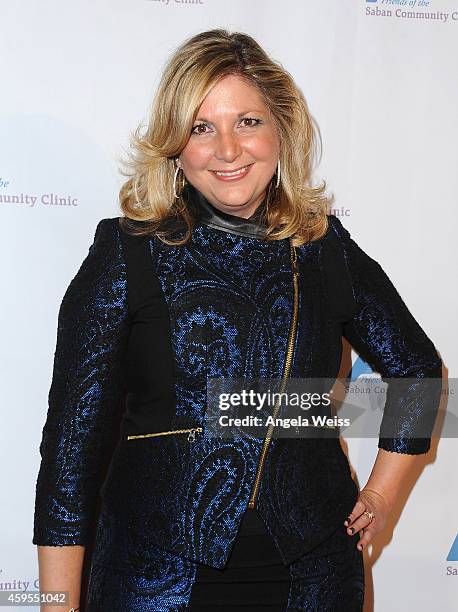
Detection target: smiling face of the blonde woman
<box><xmin>178</xmin><ymin>75</ymin><xmax>280</xmax><ymax>218</ymax></box>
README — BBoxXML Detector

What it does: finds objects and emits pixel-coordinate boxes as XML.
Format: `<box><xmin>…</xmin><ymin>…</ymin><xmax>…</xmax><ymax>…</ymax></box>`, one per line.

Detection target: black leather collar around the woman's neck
<box><xmin>183</xmin><ymin>183</ymin><xmax>267</xmax><ymax>238</ymax></box>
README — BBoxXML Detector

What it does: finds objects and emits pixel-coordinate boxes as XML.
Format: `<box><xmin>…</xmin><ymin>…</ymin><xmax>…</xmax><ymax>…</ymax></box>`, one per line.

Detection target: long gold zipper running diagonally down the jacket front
<box><xmin>248</xmin><ymin>239</ymin><xmax>299</xmax><ymax>510</ymax></box>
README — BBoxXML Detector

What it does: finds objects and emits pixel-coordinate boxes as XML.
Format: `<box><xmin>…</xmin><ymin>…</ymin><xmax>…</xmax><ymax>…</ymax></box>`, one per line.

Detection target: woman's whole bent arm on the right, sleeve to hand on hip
<box><xmin>333</xmin><ymin>218</ymin><xmax>442</xmax><ymax>547</ymax></box>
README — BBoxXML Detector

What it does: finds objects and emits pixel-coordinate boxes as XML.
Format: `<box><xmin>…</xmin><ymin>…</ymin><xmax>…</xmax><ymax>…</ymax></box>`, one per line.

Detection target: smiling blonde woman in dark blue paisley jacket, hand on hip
<box><xmin>33</xmin><ymin>30</ymin><xmax>441</xmax><ymax>612</ymax></box>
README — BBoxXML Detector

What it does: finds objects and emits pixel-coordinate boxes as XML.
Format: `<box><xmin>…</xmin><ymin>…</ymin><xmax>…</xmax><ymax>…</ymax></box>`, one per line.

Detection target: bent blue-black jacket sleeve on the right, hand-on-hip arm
<box><xmin>330</xmin><ymin>216</ymin><xmax>442</xmax><ymax>455</ymax></box>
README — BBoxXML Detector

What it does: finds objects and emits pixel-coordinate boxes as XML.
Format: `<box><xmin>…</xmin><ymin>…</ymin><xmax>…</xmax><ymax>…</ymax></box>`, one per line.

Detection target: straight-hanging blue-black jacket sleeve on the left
<box><xmin>32</xmin><ymin>218</ymin><xmax>129</xmax><ymax>546</ymax></box>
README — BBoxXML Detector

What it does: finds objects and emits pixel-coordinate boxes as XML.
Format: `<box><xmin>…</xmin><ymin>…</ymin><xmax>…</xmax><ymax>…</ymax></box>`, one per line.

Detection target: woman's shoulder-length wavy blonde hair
<box><xmin>119</xmin><ymin>29</ymin><xmax>330</xmax><ymax>246</ymax></box>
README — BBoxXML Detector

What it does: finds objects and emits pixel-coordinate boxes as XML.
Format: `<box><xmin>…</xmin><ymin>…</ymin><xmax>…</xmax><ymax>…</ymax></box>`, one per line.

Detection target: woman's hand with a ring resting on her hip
<box><xmin>344</xmin><ymin>488</ymin><xmax>390</xmax><ymax>550</ymax></box>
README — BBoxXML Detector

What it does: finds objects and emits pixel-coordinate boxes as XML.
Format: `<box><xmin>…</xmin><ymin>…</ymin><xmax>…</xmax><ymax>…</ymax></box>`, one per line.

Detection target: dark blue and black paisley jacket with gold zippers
<box><xmin>33</xmin><ymin>187</ymin><xmax>441</xmax><ymax>568</ymax></box>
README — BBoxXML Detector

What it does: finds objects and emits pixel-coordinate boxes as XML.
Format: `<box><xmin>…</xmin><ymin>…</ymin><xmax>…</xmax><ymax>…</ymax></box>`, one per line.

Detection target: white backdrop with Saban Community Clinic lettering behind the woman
<box><xmin>0</xmin><ymin>0</ymin><xmax>458</xmax><ymax>612</ymax></box>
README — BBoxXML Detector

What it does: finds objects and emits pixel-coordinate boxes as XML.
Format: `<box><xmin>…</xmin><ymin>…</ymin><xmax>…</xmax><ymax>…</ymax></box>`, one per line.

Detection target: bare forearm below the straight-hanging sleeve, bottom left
<box><xmin>37</xmin><ymin>545</ymin><xmax>85</xmax><ymax>612</ymax></box>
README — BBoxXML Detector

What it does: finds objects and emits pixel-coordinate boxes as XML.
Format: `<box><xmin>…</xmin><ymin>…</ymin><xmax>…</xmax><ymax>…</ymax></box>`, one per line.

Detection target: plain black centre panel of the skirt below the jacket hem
<box><xmin>189</xmin><ymin>510</ymin><xmax>291</xmax><ymax>612</ymax></box>
